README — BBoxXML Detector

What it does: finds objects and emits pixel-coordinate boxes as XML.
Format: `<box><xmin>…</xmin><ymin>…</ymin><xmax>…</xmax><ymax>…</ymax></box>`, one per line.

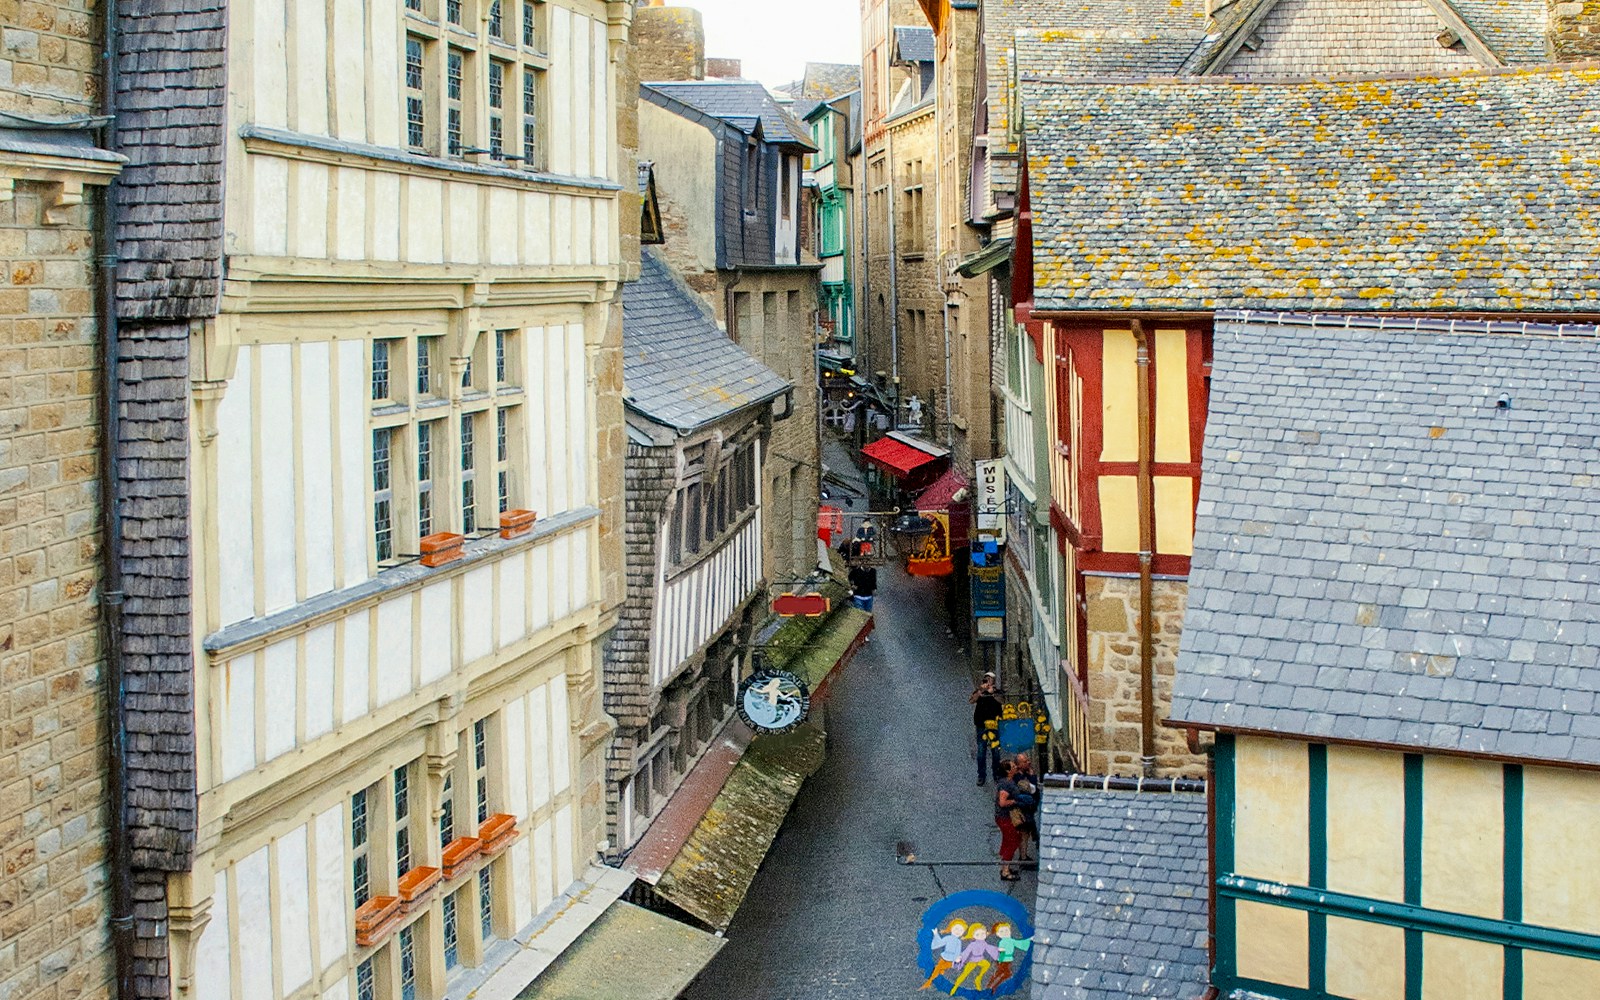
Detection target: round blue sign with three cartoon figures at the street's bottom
<box><xmin>917</xmin><ymin>890</ymin><xmax>1034</xmax><ymax>997</ymax></box>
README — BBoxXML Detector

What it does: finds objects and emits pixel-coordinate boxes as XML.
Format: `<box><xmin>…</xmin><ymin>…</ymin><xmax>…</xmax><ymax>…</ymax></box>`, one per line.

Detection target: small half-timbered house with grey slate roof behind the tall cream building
<box><xmin>605</xmin><ymin>250</ymin><xmax>794</xmax><ymax>851</ymax></box>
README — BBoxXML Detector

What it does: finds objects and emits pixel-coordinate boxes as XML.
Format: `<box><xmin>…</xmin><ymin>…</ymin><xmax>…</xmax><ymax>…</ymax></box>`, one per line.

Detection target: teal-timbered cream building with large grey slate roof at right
<box><xmin>1171</xmin><ymin>312</ymin><xmax>1600</xmax><ymax>1000</ymax></box>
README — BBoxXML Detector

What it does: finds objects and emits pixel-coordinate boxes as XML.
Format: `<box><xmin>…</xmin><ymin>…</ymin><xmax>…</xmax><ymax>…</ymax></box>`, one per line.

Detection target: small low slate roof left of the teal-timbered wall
<box><xmin>1034</xmin><ymin>786</ymin><xmax>1208</xmax><ymax>1000</ymax></box>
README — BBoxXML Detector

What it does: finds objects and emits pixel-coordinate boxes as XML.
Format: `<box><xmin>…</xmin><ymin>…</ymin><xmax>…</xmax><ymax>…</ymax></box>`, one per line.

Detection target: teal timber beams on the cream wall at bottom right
<box><xmin>1211</xmin><ymin>733</ymin><xmax>1600</xmax><ymax>1000</ymax></box>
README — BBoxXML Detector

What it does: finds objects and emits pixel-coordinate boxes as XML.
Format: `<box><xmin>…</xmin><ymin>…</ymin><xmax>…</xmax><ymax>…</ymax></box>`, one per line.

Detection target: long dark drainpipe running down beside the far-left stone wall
<box><xmin>94</xmin><ymin>0</ymin><xmax>138</xmax><ymax>1000</ymax></box>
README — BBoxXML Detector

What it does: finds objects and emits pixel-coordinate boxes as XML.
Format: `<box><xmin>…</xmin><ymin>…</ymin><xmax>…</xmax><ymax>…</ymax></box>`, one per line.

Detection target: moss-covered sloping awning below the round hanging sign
<box><xmin>649</xmin><ymin>723</ymin><xmax>826</xmax><ymax>928</ymax></box>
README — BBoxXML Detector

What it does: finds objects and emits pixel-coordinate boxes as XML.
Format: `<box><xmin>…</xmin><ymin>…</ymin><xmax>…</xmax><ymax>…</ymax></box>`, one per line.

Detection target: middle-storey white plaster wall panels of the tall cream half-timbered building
<box><xmin>202</xmin><ymin>318</ymin><xmax>597</xmax><ymax>797</ymax></box>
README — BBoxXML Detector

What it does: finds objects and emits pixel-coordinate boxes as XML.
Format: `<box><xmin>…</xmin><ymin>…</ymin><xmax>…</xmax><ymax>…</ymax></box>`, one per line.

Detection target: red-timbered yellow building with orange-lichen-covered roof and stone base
<box><xmin>1014</xmin><ymin>52</ymin><xmax>1600</xmax><ymax>773</ymax></box>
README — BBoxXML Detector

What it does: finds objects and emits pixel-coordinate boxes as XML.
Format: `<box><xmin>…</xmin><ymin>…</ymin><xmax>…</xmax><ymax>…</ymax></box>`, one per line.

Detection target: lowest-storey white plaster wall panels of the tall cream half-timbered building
<box><xmin>192</xmin><ymin>656</ymin><xmax>576</xmax><ymax>1000</ymax></box>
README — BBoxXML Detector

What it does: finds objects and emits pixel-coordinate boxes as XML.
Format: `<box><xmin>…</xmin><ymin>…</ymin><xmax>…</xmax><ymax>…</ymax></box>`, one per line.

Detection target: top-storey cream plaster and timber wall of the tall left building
<box><xmin>226</xmin><ymin>0</ymin><xmax>618</xmax><ymax>269</ymax></box>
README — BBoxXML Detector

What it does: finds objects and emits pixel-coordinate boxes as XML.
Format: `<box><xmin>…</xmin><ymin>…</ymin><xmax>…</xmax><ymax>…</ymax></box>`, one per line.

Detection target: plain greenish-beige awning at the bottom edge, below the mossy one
<box><xmin>517</xmin><ymin>901</ymin><xmax>723</xmax><ymax>1000</ymax></box>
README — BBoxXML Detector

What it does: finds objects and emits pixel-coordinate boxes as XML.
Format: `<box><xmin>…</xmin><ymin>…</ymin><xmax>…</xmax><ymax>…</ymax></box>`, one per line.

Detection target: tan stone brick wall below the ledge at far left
<box><xmin>0</xmin><ymin>175</ymin><xmax>112</xmax><ymax>1000</ymax></box>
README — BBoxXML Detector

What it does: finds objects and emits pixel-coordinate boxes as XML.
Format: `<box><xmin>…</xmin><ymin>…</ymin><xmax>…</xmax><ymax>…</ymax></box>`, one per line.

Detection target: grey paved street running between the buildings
<box><xmin>685</xmin><ymin>440</ymin><xmax>1035</xmax><ymax>1000</ymax></box>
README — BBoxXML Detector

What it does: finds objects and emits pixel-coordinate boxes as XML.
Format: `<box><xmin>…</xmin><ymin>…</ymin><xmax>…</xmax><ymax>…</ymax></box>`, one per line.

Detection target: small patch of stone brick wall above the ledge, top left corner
<box><xmin>0</xmin><ymin>0</ymin><xmax>99</xmax><ymax>115</ymax></box>
